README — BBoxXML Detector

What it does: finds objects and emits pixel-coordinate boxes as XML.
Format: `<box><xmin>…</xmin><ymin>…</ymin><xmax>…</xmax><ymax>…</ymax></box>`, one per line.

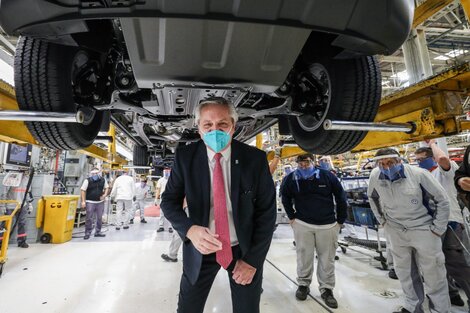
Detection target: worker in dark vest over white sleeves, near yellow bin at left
<box><xmin>80</xmin><ymin>167</ymin><xmax>109</xmax><ymax>240</ymax></box>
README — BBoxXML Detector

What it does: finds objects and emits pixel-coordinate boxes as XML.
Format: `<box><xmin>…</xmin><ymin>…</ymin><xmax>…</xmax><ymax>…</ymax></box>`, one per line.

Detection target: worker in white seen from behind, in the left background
<box><xmin>111</xmin><ymin>172</ymin><xmax>135</xmax><ymax>230</ymax></box>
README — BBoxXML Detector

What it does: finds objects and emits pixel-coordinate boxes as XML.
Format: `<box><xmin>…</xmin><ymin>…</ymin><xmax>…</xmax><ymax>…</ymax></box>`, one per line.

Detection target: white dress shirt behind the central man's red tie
<box><xmin>207</xmin><ymin>147</ymin><xmax>238</xmax><ymax>246</ymax></box>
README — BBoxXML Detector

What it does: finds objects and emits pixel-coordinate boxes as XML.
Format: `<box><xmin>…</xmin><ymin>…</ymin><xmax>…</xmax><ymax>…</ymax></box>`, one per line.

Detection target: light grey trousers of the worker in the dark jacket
<box><xmin>292</xmin><ymin>222</ymin><xmax>339</xmax><ymax>292</ymax></box>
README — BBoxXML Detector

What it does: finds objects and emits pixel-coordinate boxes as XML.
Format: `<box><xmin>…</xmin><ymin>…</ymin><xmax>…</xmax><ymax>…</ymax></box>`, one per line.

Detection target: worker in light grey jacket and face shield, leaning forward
<box><xmin>367</xmin><ymin>148</ymin><xmax>450</xmax><ymax>313</ymax></box>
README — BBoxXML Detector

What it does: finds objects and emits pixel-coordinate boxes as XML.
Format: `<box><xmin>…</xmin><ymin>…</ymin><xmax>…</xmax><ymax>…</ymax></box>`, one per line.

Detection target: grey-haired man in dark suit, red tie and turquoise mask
<box><xmin>161</xmin><ymin>98</ymin><xmax>276</xmax><ymax>313</ymax></box>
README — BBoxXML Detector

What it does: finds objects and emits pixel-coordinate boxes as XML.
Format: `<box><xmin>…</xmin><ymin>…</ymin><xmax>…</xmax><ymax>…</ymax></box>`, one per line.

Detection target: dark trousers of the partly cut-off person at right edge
<box><xmin>442</xmin><ymin>224</ymin><xmax>470</xmax><ymax>303</ymax></box>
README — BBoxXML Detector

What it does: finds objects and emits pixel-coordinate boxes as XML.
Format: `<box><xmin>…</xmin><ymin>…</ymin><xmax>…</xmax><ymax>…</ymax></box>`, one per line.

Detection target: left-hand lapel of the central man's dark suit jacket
<box><xmin>193</xmin><ymin>140</ymin><xmax>212</xmax><ymax>227</ymax></box>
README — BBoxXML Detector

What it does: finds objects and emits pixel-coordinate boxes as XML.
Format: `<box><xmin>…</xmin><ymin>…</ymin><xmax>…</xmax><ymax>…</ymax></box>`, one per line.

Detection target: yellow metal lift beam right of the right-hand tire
<box><xmin>352</xmin><ymin>63</ymin><xmax>470</xmax><ymax>152</ymax></box>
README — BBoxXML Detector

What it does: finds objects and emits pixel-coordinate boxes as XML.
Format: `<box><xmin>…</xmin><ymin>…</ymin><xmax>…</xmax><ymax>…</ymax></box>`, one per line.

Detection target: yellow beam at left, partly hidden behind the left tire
<box><xmin>0</xmin><ymin>80</ymin><xmax>127</xmax><ymax>166</ymax></box>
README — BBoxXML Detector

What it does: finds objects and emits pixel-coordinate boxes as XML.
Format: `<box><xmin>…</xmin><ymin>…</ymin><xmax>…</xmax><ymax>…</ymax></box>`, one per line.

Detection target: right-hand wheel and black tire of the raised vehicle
<box><xmin>289</xmin><ymin>56</ymin><xmax>381</xmax><ymax>155</ymax></box>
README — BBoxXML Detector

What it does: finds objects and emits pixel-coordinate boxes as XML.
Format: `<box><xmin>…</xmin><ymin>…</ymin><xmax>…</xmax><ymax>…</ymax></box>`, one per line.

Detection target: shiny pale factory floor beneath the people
<box><xmin>0</xmin><ymin>217</ymin><xmax>468</xmax><ymax>313</ymax></box>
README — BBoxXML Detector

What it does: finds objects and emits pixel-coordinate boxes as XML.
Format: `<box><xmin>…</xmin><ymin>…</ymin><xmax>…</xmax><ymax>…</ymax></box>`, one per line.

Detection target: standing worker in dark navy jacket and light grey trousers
<box><xmin>281</xmin><ymin>154</ymin><xmax>347</xmax><ymax>308</ymax></box>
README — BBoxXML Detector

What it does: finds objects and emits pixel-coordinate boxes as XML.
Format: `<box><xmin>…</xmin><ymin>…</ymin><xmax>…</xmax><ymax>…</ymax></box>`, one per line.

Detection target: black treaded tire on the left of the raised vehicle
<box><xmin>14</xmin><ymin>37</ymin><xmax>103</xmax><ymax>150</ymax></box>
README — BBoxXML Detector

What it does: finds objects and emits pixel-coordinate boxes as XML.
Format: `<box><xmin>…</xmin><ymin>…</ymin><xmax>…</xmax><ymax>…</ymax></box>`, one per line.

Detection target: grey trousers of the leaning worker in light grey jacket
<box><xmin>384</xmin><ymin>224</ymin><xmax>450</xmax><ymax>313</ymax></box>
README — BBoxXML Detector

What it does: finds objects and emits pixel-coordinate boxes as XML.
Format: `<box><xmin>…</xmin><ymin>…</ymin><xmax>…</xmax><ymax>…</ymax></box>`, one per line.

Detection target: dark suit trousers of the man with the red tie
<box><xmin>177</xmin><ymin>246</ymin><xmax>263</xmax><ymax>313</ymax></box>
